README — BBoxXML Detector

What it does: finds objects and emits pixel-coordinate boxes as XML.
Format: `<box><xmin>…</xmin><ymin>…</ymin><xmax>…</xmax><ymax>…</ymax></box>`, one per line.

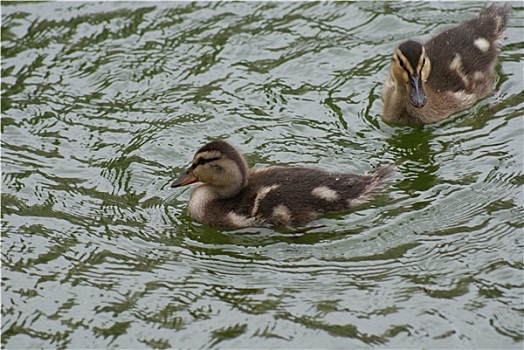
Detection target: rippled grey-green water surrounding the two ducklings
<box><xmin>2</xmin><ymin>2</ymin><xmax>524</xmax><ymax>348</ymax></box>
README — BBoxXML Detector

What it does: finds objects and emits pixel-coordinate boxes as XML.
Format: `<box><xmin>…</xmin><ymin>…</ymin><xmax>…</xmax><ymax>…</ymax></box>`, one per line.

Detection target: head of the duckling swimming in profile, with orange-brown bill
<box><xmin>171</xmin><ymin>141</ymin><xmax>247</xmax><ymax>198</ymax></box>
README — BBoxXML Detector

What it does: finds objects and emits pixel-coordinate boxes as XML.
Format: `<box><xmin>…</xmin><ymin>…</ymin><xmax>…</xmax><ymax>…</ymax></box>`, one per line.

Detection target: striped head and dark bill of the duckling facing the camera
<box><xmin>391</xmin><ymin>40</ymin><xmax>431</xmax><ymax>108</ymax></box>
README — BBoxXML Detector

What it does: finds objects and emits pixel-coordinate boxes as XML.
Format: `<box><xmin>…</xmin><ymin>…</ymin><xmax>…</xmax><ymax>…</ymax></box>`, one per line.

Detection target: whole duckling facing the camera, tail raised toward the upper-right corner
<box><xmin>382</xmin><ymin>3</ymin><xmax>511</xmax><ymax>124</ymax></box>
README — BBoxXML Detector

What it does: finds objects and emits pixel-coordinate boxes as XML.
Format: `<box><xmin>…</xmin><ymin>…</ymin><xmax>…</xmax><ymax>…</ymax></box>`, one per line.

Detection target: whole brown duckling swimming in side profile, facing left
<box><xmin>171</xmin><ymin>141</ymin><xmax>393</xmax><ymax>227</ymax></box>
